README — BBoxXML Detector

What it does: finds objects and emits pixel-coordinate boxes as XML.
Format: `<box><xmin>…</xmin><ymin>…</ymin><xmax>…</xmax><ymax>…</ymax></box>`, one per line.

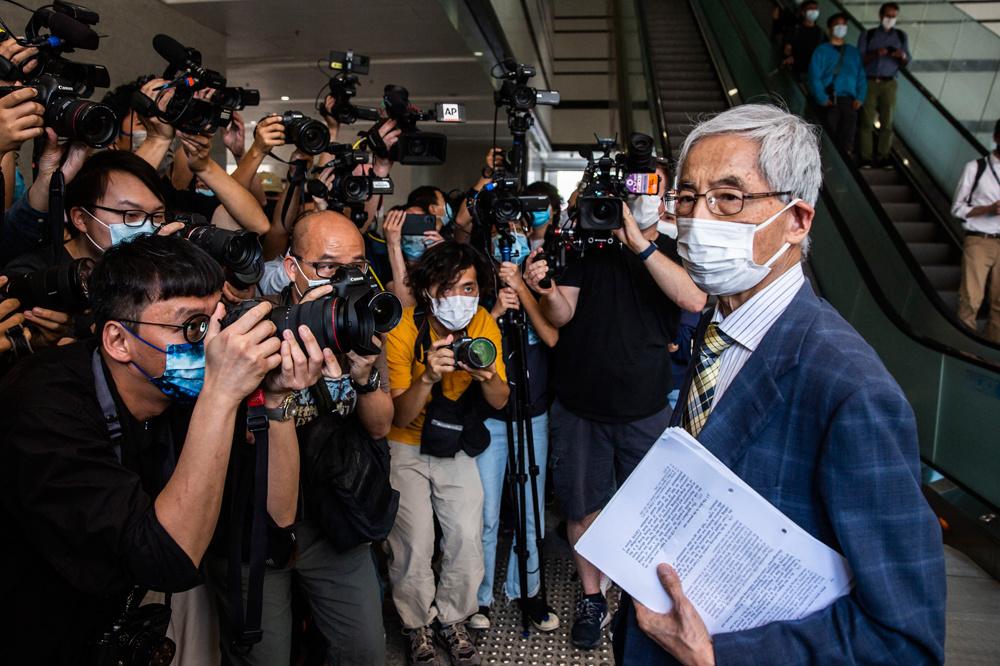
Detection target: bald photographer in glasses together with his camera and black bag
<box><xmin>209</xmin><ymin>211</ymin><xmax>401</xmax><ymax>666</ymax></box>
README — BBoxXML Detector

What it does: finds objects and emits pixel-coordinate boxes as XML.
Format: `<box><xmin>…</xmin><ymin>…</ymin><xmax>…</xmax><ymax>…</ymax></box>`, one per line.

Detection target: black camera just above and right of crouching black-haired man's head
<box><xmin>170</xmin><ymin>213</ymin><xmax>264</xmax><ymax>289</ymax></box>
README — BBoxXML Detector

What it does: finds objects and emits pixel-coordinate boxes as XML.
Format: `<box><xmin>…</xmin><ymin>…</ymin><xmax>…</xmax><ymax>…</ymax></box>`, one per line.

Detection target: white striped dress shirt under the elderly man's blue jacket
<box><xmin>712</xmin><ymin>264</ymin><xmax>805</xmax><ymax>409</ymax></box>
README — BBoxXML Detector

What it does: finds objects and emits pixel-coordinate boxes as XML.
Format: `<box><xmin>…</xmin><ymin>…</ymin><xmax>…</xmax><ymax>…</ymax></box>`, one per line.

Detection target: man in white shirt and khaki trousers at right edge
<box><xmin>951</xmin><ymin>120</ymin><xmax>1000</xmax><ymax>342</ymax></box>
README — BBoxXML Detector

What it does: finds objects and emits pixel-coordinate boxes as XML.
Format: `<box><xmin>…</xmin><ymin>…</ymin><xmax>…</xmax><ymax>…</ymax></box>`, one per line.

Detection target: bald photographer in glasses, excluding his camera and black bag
<box><xmin>210</xmin><ymin>212</ymin><xmax>393</xmax><ymax>665</ymax></box>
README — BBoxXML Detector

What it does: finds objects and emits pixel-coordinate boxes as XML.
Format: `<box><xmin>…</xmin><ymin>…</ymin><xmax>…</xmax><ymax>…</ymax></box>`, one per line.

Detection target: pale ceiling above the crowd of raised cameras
<box><xmin>163</xmin><ymin>0</ymin><xmax>504</xmax><ymax>140</ymax></box>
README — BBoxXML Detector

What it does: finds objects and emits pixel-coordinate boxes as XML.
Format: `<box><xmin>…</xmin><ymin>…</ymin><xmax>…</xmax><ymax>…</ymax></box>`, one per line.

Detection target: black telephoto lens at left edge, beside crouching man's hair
<box><xmin>2</xmin><ymin>258</ymin><xmax>94</xmax><ymax>314</ymax></box>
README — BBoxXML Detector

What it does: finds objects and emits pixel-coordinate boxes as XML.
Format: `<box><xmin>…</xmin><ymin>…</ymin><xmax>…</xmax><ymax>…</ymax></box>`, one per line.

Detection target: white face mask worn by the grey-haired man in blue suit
<box><xmin>677</xmin><ymin>199</ymin><xmax>800</xmax><ymax>296</ymax></box>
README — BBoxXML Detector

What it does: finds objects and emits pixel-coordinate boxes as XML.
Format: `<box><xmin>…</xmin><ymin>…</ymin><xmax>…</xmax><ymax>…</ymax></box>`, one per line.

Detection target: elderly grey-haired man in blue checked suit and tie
<box><xmin>614</xmin><ymin>105</ymin><xmax>945</xmax><ymax>666</ymax></box>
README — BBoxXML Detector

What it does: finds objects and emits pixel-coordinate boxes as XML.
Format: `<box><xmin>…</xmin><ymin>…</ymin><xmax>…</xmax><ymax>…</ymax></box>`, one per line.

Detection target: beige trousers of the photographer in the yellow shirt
<box><xmin>388</xmin><ymin>441</ymin><xmax>483</xmax><ymax>629</ymax></box>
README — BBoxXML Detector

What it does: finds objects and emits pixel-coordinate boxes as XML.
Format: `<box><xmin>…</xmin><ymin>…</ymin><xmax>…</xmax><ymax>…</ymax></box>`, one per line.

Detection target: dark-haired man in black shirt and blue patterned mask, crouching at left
<box><xmin>0</xmin><ymin>235</ymin><xmax>323</xmax><ymax>664</ymax></box>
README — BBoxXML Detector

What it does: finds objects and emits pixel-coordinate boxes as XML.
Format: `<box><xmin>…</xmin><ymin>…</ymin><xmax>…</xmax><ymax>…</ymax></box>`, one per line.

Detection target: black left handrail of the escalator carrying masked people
<box><xmin>721</xmin><ymin>0</ymin><xmax>1000</xmax><ymax>356</ymax></box>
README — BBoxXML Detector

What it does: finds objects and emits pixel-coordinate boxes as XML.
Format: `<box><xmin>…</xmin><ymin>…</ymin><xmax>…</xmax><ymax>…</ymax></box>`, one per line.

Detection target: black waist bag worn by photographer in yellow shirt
<box><xmin>413</xmin><ymin>311</ymin><xmax>491</xmax><ymax>458</ymax></box>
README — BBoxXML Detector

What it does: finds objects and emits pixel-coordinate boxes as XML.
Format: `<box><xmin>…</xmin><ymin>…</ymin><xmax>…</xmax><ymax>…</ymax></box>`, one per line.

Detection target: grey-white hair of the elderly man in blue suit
<box><xmin>677</xmin><ymin>104</ymin><xmax>823</xmax><ymax>259</ymax></box>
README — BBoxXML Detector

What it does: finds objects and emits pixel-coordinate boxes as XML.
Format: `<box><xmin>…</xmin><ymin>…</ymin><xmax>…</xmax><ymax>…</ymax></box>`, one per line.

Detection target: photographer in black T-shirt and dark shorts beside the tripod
<box><xmin>525</xmin><ymin>202</ymin><xmax>706</xmax><ymax>649</ymax></box>
